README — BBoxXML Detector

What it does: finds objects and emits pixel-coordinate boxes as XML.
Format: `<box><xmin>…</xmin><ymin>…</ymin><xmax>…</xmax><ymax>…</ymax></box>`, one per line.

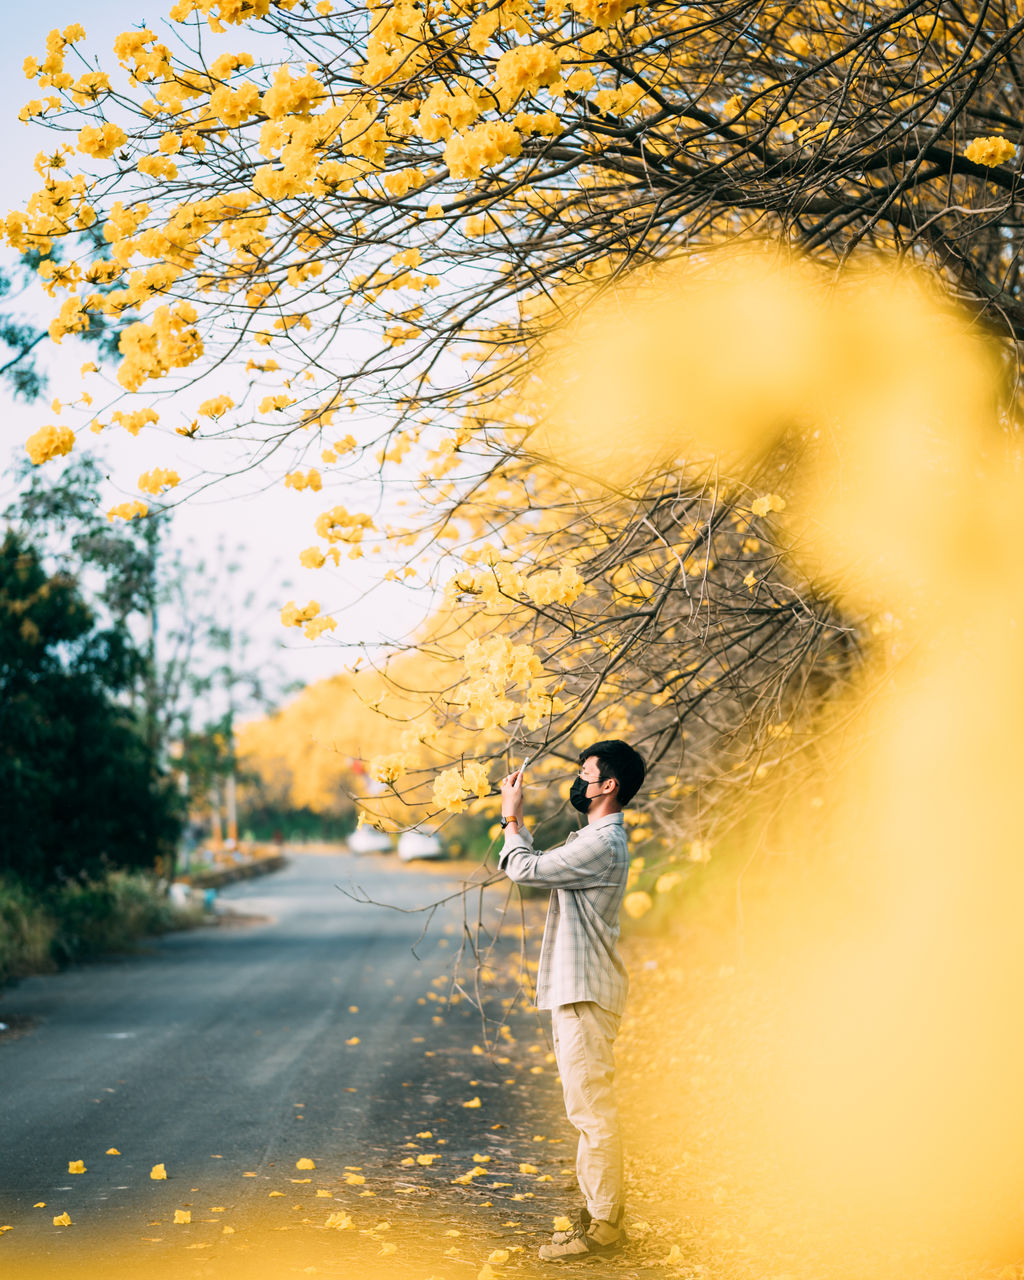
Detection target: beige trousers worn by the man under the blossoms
<box><xmin>552</xmin><ymin>1000</ymin><xmax>625</xmax><ymax>1221</ymax></box>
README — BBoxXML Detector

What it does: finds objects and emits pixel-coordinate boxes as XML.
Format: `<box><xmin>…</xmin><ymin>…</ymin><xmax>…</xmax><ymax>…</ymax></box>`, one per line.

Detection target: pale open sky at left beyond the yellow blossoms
<box><xmin>0</xmin><ymin>0</ymin><xmax>430</xmax><ymax>696</ymax></box>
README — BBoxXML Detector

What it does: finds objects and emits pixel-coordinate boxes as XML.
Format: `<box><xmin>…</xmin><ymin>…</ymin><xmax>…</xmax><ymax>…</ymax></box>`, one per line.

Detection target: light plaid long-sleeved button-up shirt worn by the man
<box><xmin>498</xmin><ymin>813</ymin><xmax>630</xmax><ymax>1015</ymax></box>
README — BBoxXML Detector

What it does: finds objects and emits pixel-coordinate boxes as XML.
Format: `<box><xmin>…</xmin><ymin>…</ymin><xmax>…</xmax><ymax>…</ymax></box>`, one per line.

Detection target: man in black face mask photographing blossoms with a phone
<box><xmin>499</xmin><ymin>740</ymin><xmax>646</xmax><ymax>1262</ymax></box>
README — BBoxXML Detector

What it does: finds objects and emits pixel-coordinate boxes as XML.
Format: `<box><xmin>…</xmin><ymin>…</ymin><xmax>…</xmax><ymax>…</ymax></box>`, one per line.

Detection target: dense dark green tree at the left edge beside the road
<box><xmin>0</xmin><ymin>529</ymin><xmax>179</xmax><ymax>884</ymax></box>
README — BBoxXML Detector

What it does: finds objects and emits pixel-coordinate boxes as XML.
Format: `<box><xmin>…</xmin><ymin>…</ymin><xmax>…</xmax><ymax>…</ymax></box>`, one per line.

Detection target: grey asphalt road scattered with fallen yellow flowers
<box><xmin>0</xmin><ymin>854</ymin><xmax>581</xmax><ymax>1280</ymax></box>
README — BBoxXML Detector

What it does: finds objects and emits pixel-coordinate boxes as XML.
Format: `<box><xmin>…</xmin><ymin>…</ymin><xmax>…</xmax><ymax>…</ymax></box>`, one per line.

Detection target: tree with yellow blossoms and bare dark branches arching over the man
<box><xmin>4</xmin><ymin>0</ymin><xmax>1024</xmax><ymax>839</ymax></box>
